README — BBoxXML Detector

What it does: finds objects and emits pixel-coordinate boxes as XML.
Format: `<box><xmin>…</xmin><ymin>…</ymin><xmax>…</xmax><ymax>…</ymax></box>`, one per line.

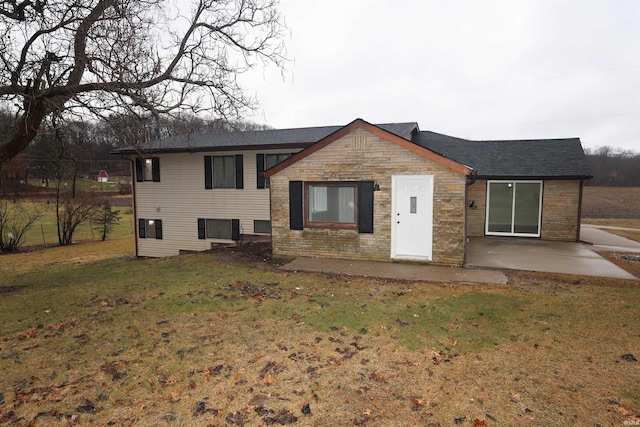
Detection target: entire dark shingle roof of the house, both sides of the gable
<box><xmin>114</xmin><ymin>122</ymin><xmax>590</xmax><ymax>178</ymax></box>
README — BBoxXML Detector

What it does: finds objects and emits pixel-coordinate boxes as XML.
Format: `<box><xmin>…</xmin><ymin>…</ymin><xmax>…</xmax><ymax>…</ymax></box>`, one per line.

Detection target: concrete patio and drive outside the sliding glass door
<box><xmin>467</xmin><ymin>228</ymin><xmax>640</xmax><ymax>279</ymax></box>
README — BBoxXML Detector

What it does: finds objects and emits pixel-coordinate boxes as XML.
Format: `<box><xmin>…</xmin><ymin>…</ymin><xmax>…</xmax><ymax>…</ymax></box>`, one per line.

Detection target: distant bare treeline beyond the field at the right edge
<box><xmin>585</xmin><ymin>146</ymin><xmax>640</xmax><ymax>187</ymax></box>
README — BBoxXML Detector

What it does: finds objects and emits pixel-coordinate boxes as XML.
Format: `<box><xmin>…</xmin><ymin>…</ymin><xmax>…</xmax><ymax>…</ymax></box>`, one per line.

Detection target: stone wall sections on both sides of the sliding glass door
<box><xmin>467</xmin><ymin>180</ymin><xmax>580</xmax><ymax>241</ymax></box>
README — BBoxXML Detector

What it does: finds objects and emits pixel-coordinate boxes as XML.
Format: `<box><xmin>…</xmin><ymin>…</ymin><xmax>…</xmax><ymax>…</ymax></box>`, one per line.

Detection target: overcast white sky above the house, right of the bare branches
<box><xmin>240</xmin><ymin>0</ymin><xmax>640</xmax><ymax>152</ymax></box>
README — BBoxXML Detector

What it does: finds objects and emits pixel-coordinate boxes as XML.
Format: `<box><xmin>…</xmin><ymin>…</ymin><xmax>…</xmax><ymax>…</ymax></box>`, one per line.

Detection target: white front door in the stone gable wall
<box><xmin>391</xmin><ymin>175</ymin><xmax>433</xmax><ymax>261</ymax></box>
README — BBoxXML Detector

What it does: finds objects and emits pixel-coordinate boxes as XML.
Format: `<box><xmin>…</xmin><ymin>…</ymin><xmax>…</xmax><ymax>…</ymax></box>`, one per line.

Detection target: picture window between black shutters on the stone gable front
<box><xmin>306</xmin><ymin>183</ymin><xmax>357</xmax><ymax>228</ymax></box>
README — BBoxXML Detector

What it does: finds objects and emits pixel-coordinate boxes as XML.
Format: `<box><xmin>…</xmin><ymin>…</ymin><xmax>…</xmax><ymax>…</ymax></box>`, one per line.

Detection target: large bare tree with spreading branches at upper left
<box><xmin>0</xmin><ymin>0</ymin><xmax>284</xmax><ymax>164</ymax></box>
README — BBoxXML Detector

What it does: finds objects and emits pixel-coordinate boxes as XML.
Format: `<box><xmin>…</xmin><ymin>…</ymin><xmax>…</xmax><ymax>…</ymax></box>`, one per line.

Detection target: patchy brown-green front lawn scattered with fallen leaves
<box><xmin>0</xmin><ymin>242</ymin><xmax>640</xmax><ymax>426</ymax></box>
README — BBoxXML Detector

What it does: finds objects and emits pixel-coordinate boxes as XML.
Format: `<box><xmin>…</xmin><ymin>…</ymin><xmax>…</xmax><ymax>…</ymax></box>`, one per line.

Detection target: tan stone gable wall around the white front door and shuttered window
<box><xmin>270</xmin><ymin>128</ymin><xmax>466</xmax><ymax>265</ymax></box>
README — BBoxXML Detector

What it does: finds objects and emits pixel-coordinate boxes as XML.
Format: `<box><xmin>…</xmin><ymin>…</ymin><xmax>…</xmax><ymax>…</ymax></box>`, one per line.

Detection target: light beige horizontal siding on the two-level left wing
<box><xmin>134</xmin><ymin>149</ymin><xmax>296</xmax><ymax>257</ymax></box>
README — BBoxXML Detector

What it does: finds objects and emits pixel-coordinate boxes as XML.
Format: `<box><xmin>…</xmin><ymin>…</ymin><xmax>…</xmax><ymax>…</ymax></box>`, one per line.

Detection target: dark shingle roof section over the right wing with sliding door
<box><xmin>413</xmin><ymin>131</ymin><xmax>590</xmax><ymax>178</ymax></box>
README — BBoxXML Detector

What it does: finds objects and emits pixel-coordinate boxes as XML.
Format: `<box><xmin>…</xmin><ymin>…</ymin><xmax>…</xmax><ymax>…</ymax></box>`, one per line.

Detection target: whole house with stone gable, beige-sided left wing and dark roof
<box><xmin>116</xmin><ymin>119</ymin><xmax>591</xmax><ymax>265</ymax></box>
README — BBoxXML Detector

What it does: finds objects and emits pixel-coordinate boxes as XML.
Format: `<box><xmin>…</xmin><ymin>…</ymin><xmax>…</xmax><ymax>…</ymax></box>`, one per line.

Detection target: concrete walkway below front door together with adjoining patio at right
<box><xmin>282</xmin><ymin>226</ymin><xmax>640</xmax><ymax>284</ymax></box>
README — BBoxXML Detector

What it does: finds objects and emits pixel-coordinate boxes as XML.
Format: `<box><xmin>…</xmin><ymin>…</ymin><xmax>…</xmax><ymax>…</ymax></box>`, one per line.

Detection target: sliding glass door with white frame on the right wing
<box><xmin>485</xmin><ymin>181</ymin><xmax>542</xmax><ymax>237</ymax></box>
